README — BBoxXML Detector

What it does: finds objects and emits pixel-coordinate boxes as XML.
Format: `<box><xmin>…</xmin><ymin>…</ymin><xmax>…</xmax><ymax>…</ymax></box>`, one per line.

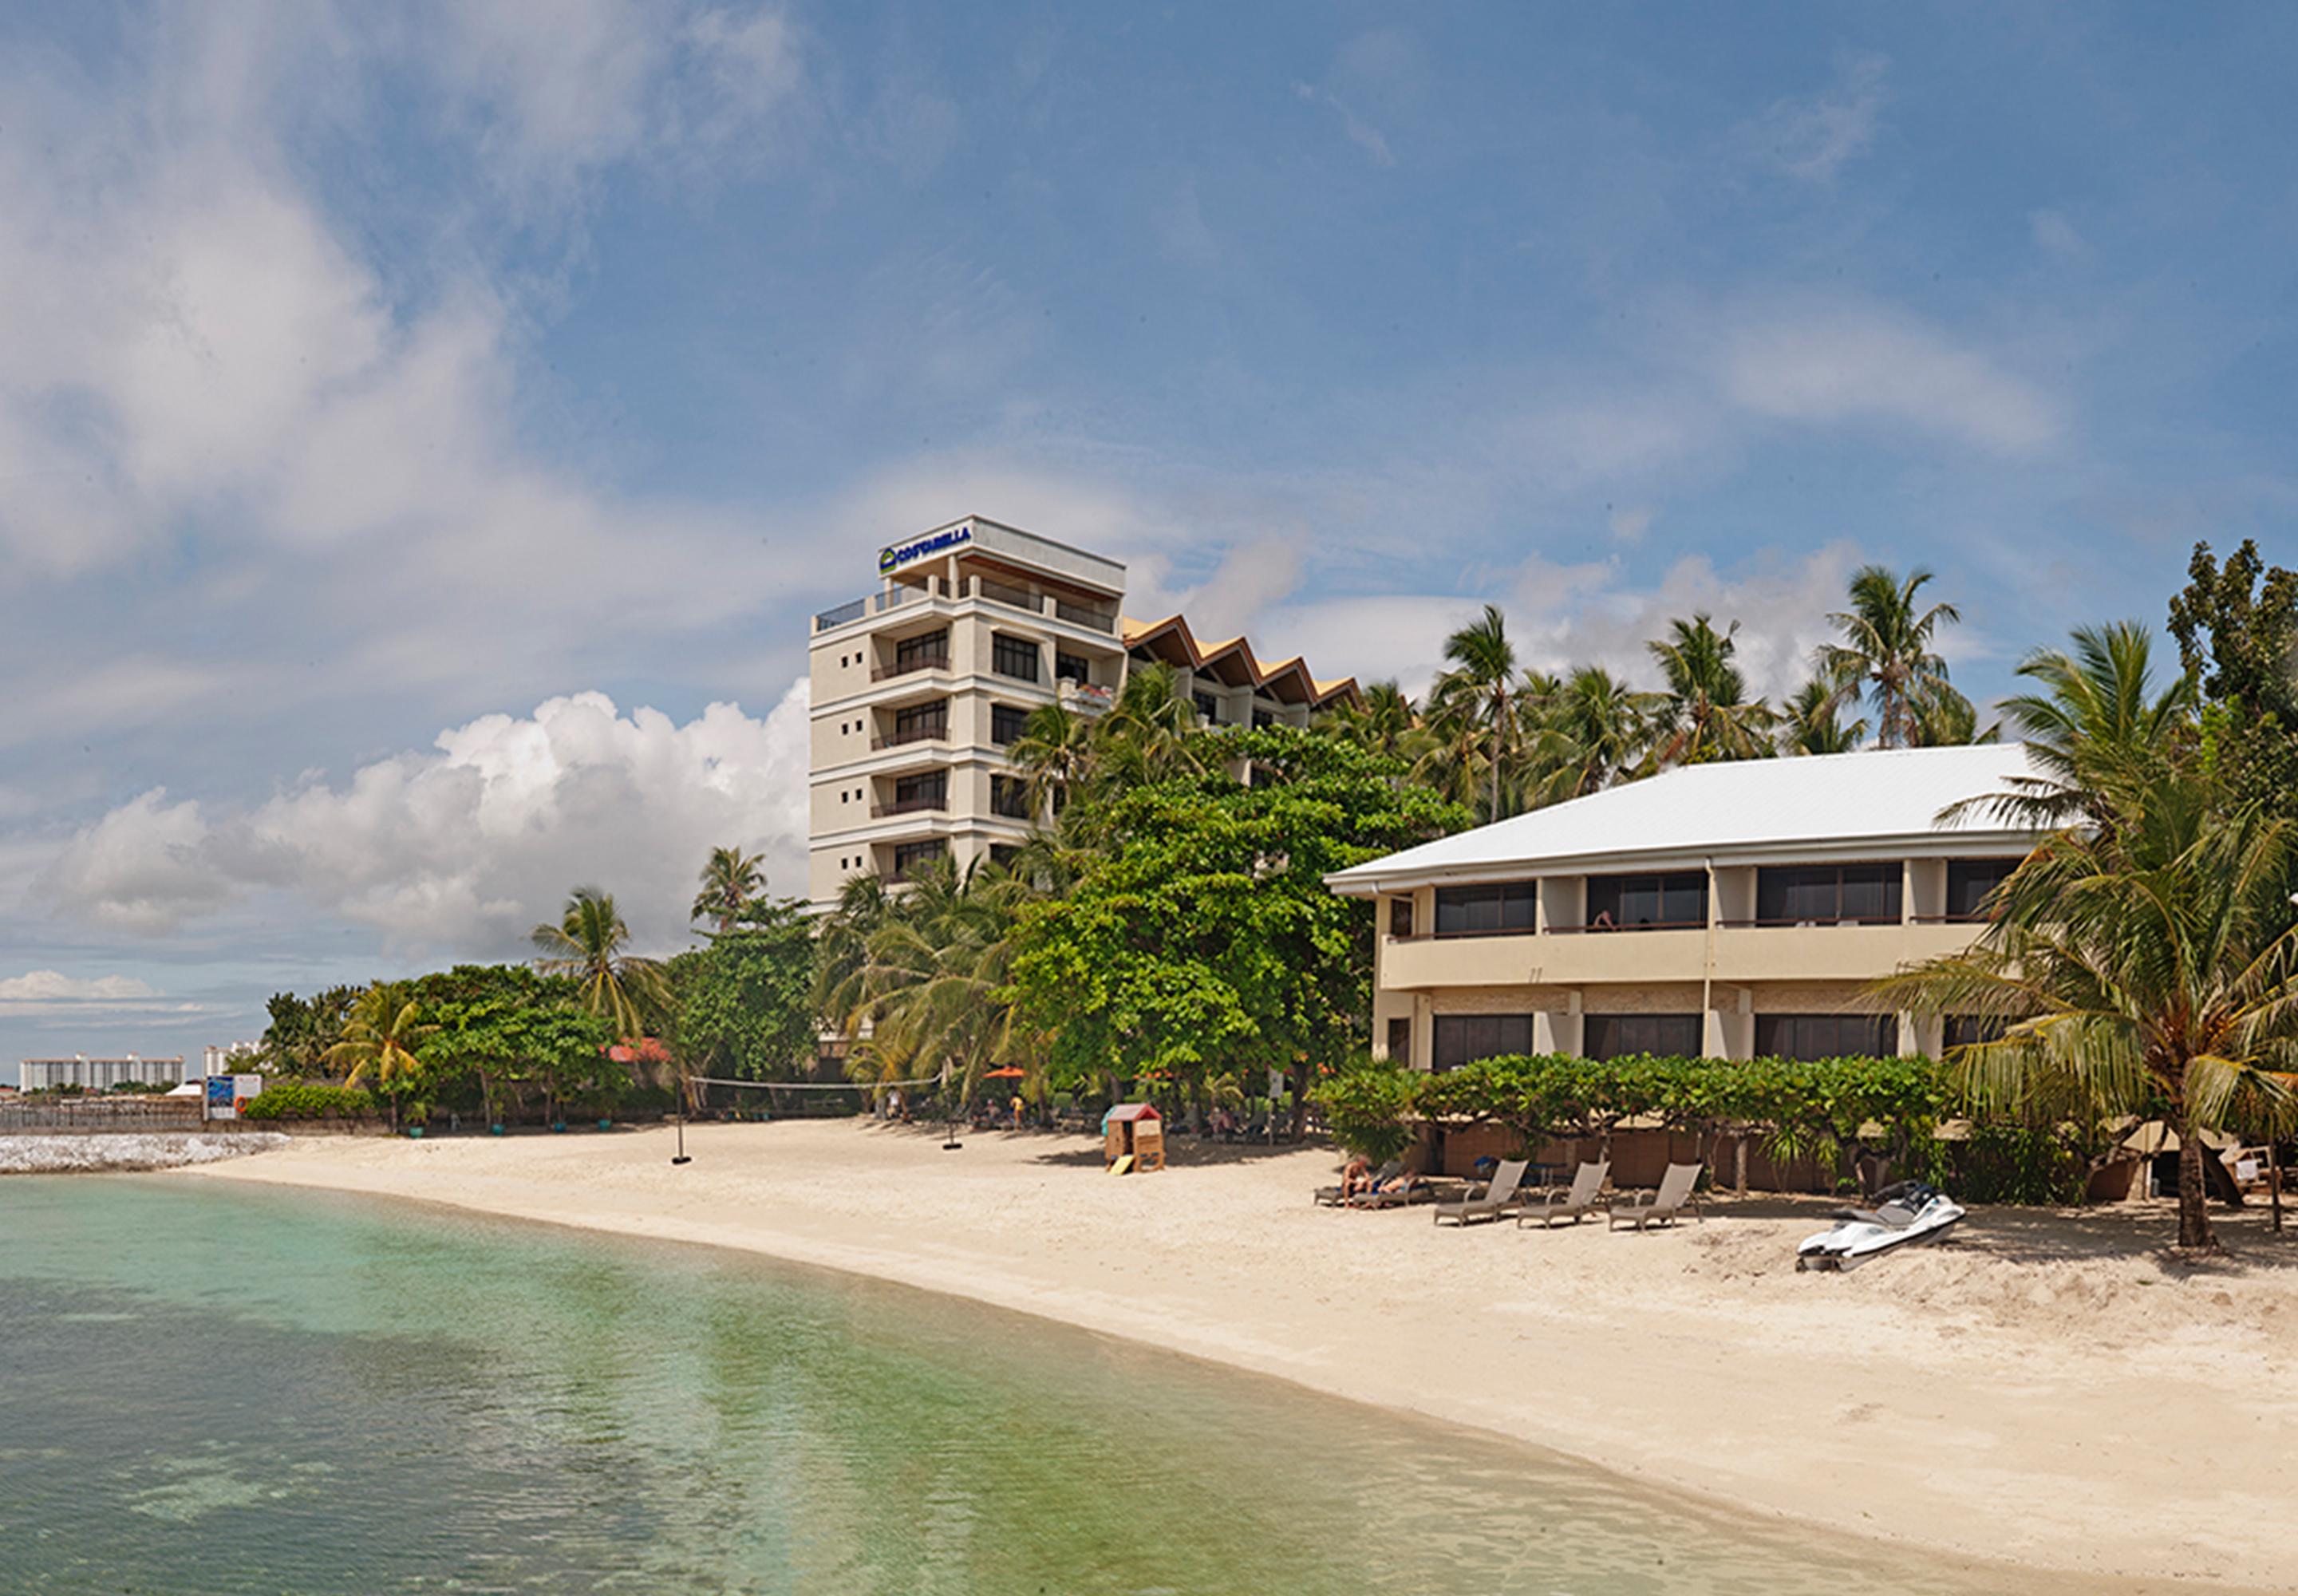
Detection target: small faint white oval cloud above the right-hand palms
<box><xmin>1716</xmin><ymin>303</ymin><xmax>2061</xmax><ymax>456</ymax></box>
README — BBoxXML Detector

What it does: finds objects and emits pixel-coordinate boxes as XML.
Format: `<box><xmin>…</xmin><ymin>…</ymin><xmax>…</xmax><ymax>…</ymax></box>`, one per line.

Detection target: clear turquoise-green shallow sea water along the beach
<box><xmin>0</xmin><ymin>1175</ymin><xmax>2031</xmax><ymax>1596</ymax></box>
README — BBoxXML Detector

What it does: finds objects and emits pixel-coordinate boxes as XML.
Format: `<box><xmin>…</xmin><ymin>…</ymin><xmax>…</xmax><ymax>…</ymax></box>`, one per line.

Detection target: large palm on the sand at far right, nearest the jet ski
<box><xmin>1875</xmin><ymin>764</ymin><xmax>2298</xmax><ymax>1251</ymax></box>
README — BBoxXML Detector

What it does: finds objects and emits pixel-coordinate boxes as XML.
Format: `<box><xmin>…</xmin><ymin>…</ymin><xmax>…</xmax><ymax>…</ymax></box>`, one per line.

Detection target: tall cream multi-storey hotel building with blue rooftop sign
<box><xmin>807</xmin><ymin>516</ymin><xmax>1356</xmax><ymax>908</ymax></box>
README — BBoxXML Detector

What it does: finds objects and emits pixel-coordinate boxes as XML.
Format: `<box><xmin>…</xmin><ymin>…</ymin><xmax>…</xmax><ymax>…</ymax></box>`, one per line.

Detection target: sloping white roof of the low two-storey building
<box><xmin>1326</xmin><ymin>743</ymin><xmax>2031</xmax><ymax>895</ymax></box>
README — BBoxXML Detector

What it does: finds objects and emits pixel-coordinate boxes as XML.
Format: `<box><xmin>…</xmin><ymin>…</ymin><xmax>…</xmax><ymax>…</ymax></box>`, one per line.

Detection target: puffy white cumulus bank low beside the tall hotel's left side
<box><xmin>39</xmin><ymin>681</ymin><xmax>807</xmax><ymax>957</ymax></box>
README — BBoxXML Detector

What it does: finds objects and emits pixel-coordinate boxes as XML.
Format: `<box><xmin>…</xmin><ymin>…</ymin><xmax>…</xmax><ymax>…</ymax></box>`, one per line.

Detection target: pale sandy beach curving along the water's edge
<box><xmin>186</xmin><ymin>1122</ymin><xmax>2298</xmax><ymax>1589</ymax></box>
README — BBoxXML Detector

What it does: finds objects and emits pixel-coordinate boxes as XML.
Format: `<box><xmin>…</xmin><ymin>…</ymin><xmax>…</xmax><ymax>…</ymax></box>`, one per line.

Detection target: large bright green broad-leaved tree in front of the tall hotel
<box><xmin>1011</xmin><ymin>727</ymin><xmax>1468</xmax><ymax>1131</ymax></box>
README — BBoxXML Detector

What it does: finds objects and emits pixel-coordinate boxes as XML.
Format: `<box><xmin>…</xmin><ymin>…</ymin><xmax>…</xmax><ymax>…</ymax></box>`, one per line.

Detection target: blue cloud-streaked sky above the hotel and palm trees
<box><xmin>0</xmin><ymin>0</ymin><xmax>2298</xmax><ymax>1079</ymax></box>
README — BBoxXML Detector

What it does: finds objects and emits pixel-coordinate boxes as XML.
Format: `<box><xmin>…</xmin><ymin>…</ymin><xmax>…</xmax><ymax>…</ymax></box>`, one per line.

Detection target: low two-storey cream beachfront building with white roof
<box><xmin>1331</xmin><ymin>745</ymin><xmax>2034</xmax><ymax>1069</ymax></box>
